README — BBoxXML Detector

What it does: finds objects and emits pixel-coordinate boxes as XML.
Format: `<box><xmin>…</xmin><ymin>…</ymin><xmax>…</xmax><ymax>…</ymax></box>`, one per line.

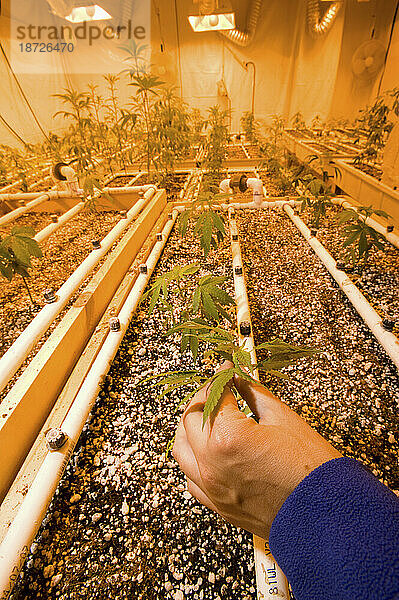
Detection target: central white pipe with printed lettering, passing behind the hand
<box><xmin>229</xmin><ymin>210</ymin><xmax>290</xmax><ymax>600</ymax></box>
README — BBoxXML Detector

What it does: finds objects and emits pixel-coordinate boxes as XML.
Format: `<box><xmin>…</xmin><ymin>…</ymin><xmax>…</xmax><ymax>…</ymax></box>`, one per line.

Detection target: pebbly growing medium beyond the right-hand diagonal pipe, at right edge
<box><xmin>300</xmin><ymin>207</ymin><xmax>399</xmax><ymax>335</ymax></box>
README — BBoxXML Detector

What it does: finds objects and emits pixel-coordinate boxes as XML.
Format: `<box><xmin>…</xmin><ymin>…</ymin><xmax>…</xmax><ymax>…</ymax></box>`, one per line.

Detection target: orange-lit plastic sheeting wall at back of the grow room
<box><xmin>0</xmin><ymin>0</ymin><xmax>399</xmax><ymax>144</ymax></box>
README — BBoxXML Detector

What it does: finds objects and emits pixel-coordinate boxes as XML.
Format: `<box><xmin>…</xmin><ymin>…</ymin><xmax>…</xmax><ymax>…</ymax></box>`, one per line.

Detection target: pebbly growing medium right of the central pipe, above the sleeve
<box><xmin>237</xmin><ymin>209</ymin><xmax>399</xmax><ymax>491</ymax></box>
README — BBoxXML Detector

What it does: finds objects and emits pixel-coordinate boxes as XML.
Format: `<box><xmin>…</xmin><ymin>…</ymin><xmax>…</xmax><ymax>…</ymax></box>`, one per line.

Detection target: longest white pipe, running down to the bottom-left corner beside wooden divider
<box><xmin>0</xmin><ymin>211</ymin><xmax>177</xmax><ymax>600</ymax></box>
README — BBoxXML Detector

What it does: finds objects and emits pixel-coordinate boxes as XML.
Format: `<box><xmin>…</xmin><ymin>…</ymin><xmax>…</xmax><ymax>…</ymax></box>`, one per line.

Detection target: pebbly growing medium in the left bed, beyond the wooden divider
<box><xmin>0</xmin><ymin>212</ymin><xmax>121</xmax><ymax>356</ymax></box>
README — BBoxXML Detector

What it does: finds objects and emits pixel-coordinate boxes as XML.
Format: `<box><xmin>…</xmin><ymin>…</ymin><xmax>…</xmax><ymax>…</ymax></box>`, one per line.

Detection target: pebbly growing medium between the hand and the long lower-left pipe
<box><xmin>12</xmin><ymin>220</ymin><xmax>256</xmax><ymax>600</ymax></box>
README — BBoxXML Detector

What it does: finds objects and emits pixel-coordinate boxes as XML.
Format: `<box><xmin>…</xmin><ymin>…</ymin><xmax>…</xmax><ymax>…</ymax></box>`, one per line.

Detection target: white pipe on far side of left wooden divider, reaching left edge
<box><xmin>0</xmin><ymin>185</ymin><xmax>156</xmax><ymax>391</ymax></box>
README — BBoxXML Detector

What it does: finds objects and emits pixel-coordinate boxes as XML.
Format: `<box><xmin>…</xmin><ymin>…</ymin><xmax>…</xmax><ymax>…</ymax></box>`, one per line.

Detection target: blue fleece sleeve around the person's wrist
<box><xmin>269</xmin><ymin>458</ymin><xmax>399</xmax><ymax>600</ymax></box>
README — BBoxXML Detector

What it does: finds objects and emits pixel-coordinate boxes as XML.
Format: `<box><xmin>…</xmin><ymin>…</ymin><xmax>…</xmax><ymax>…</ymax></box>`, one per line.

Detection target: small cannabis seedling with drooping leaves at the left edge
<box><xmin>0</xmin><ymin>227</ymin><xmax>43</xmax><ymax>304</ymax></box>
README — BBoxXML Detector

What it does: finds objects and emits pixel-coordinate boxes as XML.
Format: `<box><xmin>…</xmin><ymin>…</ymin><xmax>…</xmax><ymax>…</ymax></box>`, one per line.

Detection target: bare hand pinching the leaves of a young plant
<box><xmin>173</xmin><ymin>362</ymin><xmax>341</xmax><ymax>538</ymax></box>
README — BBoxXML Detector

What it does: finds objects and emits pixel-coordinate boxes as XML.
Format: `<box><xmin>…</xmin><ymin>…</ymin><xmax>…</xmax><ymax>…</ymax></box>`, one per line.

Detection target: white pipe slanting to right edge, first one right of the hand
<box><xmin>283</xmin><ymin>205</ymin><xmax>399</xmax><ymax>368</ymax></box>
